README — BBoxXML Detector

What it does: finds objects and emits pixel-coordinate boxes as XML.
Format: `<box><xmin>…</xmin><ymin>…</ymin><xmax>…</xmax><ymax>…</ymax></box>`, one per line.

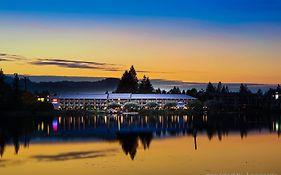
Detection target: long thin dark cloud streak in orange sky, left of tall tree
<box><xmin>30</xmin><ymin>58</ymin><xmax>120</xmax><ymax>72</ymax></box>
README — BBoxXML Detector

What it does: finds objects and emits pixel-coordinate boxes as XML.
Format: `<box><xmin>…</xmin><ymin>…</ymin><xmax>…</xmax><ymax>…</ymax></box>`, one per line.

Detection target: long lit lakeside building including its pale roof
<box><xmin>51</xmin><ymin>93</ymin><xmax>196</xmax><ymax>110</ymax></box>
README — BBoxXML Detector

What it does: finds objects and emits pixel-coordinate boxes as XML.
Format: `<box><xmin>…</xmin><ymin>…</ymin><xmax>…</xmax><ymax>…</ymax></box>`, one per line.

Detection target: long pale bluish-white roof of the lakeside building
<box><xmin>54</xmin><ymin>93</ymin><xmax>196</xmax><ymax>100</ymax></box>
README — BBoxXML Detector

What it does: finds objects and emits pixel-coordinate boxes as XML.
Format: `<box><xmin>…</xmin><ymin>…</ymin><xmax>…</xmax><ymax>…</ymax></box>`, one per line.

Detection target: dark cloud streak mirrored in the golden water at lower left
<box><xmin>31</xmin><ymin>149</ymin><xmax>117</xmax><ymax>161</ymax></box>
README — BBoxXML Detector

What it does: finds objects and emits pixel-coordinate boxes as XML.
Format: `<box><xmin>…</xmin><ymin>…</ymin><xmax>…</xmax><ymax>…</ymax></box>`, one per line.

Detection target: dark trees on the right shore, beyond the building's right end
<box><xmin>192</xmin><ymin>82</ymin><xmax>281</xmax><ymax>114</ymax></box>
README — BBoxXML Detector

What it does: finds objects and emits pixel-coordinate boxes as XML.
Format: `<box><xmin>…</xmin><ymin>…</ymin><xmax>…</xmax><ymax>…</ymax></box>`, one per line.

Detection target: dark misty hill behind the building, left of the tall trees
<box><xmin>3</xmin><ymin>76</ymin><xmax>119</xmax><ymax>93</ymax></box>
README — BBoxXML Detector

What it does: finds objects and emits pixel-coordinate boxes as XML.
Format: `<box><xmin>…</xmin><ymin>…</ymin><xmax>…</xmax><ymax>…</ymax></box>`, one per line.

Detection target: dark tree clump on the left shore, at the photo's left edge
<box><xmin>0</xmin><ymin>69</ymin><xmax>53</xmax><ymax>111</ymax></box>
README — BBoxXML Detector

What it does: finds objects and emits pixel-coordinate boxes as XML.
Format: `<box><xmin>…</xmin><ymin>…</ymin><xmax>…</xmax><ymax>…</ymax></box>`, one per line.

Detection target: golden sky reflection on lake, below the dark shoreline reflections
<box><xmin>0</xmin><ymin>134</ymin><xmax>281</xmax><ymax>175</ymax></box>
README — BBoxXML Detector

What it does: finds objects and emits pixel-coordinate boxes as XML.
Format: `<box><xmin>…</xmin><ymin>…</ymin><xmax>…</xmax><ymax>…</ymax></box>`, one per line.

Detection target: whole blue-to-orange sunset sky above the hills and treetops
<box><xmin>0</xmin><ymin>0</ymin><xmax>281</xmax><ymax>84</ymax></box>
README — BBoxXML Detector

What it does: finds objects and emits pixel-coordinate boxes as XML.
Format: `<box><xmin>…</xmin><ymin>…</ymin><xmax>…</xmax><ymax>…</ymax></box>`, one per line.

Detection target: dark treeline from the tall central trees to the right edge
<box><xmin>115</xmin><ymin>66</ymin><xmax>281</xmax><ymax>112</ymax></box>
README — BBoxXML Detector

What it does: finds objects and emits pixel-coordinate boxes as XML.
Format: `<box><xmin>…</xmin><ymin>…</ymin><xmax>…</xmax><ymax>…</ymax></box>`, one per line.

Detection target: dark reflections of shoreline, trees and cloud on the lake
<box><xmin>0</xmin><ymin>115</ymin><xmax>280</xmax><ymax>160</ymax></box>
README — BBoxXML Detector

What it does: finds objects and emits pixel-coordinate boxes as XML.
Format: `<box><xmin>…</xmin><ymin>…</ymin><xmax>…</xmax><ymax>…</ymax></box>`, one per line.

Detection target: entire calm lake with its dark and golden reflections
<box><xmin>0</xmin><ymin>115</ymin><xmax>281</xmax><ymax>175</ymax></box>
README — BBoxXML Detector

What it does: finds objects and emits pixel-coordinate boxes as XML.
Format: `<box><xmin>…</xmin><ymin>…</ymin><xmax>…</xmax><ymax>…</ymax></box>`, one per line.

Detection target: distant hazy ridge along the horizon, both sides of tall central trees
<box><xmin>3</xmin><ymin>75</ymin><xmax>277</xmax><ymax>93</ymax></box>
